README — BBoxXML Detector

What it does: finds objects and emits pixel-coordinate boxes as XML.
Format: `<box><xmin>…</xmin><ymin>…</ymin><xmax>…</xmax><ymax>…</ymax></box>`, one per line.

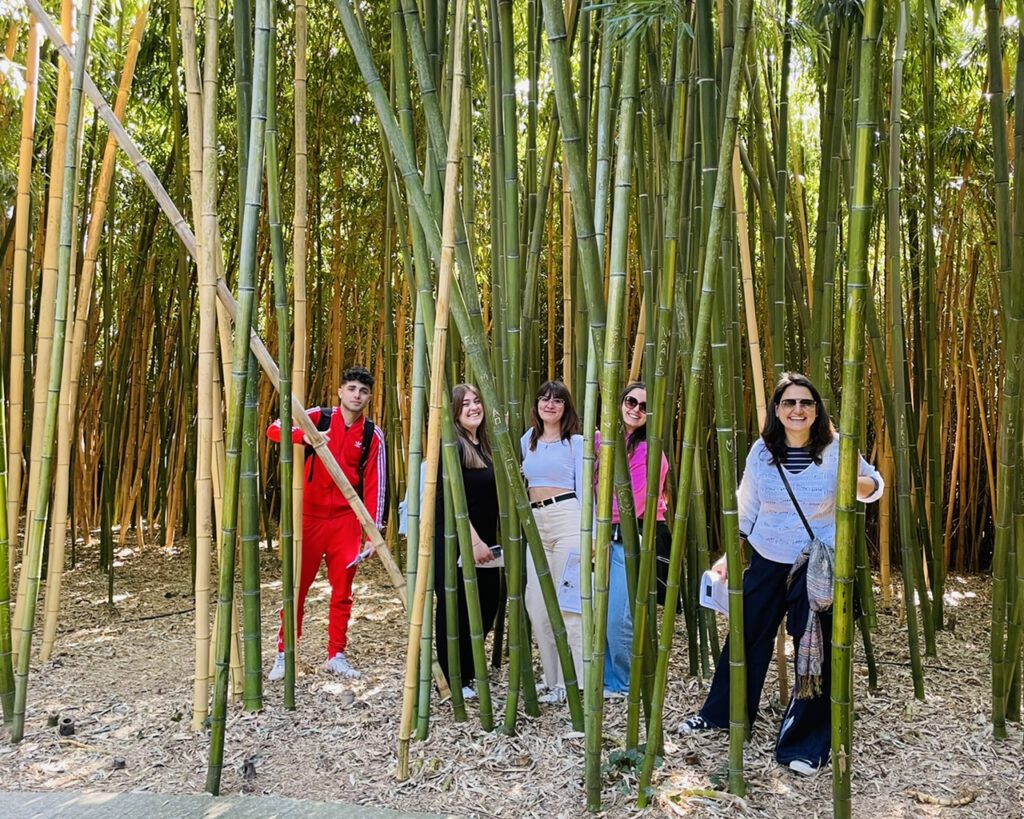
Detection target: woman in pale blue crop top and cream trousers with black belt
<box><xmin>520</xmin><ymin>381</ymin><xmax>583</xmax><ymax>702</ymax></box>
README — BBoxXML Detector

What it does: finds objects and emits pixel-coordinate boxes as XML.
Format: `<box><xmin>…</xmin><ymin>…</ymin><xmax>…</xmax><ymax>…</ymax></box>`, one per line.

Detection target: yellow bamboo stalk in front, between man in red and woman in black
<box><xmin>396</xmin><ymin>0</ymin><xmax>466</xmax><ymax>781</ymax></box>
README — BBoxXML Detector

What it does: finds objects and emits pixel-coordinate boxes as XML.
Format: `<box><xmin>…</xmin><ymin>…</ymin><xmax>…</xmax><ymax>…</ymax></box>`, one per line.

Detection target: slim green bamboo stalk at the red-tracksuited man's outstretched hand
<box><xmin>266</xmin><ymin>3</ymin><xmax>296</xmax><ymax>710</ymax></box>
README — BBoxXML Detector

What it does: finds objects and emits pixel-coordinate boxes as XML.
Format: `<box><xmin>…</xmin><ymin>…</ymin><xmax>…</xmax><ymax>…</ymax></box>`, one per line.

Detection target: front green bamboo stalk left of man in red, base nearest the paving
<box><xmin>206</xmin><ymin>0</ymin><xmax>270</xmax><ymax>795</ymax></box>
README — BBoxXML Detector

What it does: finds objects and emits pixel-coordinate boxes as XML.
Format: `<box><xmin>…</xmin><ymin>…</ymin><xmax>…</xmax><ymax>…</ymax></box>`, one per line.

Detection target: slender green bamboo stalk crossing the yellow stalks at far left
<box><xmin>10</xmin><ymin>0</ymin><xmax>93</xmax><ymax>742</ymax></box>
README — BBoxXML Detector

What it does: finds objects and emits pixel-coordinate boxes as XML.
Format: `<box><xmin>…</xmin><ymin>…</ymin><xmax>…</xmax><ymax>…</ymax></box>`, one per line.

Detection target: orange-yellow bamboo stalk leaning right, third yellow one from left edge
<box><xmin>40</xmin><ymin>2</ymin><xmax>150</xmax><ymax>662</ymax></box>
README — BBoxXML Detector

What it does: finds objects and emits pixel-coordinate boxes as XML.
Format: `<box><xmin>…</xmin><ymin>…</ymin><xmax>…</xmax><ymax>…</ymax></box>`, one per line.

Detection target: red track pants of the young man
<box><xmin>278</xmin><ymin>510</ymin><xmax>362</xmax><ymax>658</ymax></box>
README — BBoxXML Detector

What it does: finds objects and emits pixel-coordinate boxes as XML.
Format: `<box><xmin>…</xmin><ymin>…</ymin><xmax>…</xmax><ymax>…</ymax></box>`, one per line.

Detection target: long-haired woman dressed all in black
<box><xmin>434</xmin><ymin>384</ymin><xmax>501</xmax><ymax>698</ymax></box>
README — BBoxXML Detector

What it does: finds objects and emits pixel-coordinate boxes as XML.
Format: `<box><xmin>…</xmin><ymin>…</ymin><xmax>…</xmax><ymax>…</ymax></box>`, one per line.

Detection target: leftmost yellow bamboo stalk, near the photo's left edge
<box><xmin>6</xmin><ymin>16</ymin><xmax>39</xmax><ymax>544</ymax></box>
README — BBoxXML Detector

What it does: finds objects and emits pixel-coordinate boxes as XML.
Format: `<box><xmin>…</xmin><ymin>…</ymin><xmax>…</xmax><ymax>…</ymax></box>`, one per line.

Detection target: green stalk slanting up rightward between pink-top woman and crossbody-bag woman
<box><xmin>638</xmin><ymin>0</ymin><xmax>753</xmax><ymax>807</ymax></box>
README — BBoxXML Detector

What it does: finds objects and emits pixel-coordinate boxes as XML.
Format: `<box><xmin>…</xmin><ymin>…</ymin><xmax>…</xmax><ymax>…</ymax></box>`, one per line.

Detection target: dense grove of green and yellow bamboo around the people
<box><xmin>0</xmin><ymin>0</ymin><xmax>1024</xmax><ymax>816</ymax></box>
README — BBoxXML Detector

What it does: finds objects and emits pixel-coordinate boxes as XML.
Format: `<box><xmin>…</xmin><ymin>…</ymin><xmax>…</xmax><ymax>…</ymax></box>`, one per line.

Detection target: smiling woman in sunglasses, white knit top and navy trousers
<box><xmin>679</xmin><ymin>373</ymin><xmax>885</xmax><ymax>774</ymax></box>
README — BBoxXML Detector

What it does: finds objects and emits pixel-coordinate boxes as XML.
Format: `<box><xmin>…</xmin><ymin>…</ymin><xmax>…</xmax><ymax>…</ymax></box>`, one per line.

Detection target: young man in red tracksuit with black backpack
<box><xmin>266</xmin><ymin>367</ymin><xmax>387</xmax><ymax>681</ymax></box>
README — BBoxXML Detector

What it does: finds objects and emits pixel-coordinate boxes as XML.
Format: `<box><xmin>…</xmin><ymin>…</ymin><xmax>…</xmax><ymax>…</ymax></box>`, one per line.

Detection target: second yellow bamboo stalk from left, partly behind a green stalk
<box><xmin>14</xmin><ymin>0</ymin><xmax>75</xmax><ymax>647</ymax></box>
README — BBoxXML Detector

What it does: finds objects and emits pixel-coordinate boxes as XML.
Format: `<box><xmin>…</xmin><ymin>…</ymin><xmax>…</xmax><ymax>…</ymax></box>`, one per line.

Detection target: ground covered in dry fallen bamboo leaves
<box><xmin>0</xmin><ymin>547</ymin><xmax>1024</xmax><ymax>819</ymax></box>
